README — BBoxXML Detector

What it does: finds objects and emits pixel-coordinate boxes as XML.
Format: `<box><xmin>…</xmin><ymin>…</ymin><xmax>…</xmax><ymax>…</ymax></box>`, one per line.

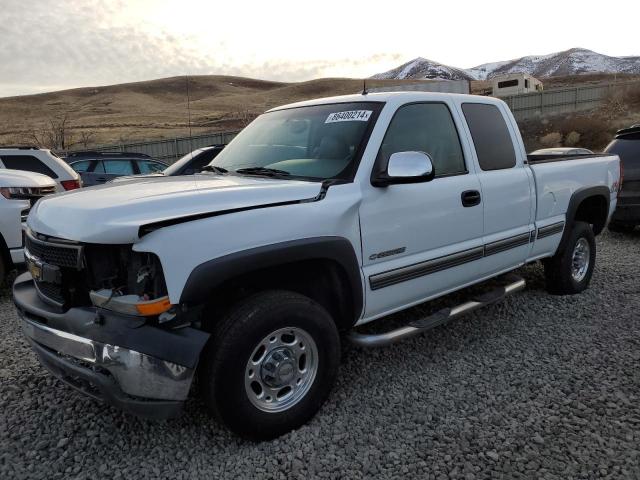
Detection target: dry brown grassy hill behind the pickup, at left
<box><xmin>0</xmin><ymin>75</ymin><xmax>424</xmax><ymax>147</ymax></box>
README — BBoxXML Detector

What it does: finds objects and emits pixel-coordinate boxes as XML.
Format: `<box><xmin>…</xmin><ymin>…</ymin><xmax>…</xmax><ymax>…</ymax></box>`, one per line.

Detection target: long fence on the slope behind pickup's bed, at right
<box><xmin>500</xmin><ymin>81</ymin><xmax>640</xmax><ymax>120</ymax></box>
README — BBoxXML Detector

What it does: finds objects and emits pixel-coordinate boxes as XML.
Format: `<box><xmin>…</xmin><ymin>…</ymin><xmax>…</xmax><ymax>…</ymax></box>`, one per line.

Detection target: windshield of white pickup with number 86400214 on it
<box><xmin>211</xmin><ymin>102</ymin><xmax>382</xmax><ymax>181</ymax></box>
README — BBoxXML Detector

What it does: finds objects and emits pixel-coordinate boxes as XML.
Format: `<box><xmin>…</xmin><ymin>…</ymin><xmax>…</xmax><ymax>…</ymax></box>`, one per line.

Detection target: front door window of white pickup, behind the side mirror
<box><xmin>378</xmin><ymin>103</ymin><xmax>466</xmax><ymax>177</ymax></box>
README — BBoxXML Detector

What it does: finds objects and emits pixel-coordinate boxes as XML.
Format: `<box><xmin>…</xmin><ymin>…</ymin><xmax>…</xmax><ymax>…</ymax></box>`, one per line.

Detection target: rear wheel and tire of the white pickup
<box><xmin>543</xmin><ymin>222</ymin><xmax>596</xmax><ymax>295</ymax></box>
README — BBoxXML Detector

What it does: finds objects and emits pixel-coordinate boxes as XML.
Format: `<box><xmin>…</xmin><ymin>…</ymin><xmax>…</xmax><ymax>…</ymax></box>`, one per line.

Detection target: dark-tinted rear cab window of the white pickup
<box><xmin>462</xmin><ymin>103</ymin><xmax>516</xmax><ymax>171</ymax></box>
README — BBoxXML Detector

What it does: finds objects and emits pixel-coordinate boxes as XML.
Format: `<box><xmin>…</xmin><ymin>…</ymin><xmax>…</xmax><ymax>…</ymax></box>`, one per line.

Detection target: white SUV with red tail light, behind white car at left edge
<box><xmin>0</xmin><ymin>146</ymin><xmax>82</xmax><ymax>192</ymax></box>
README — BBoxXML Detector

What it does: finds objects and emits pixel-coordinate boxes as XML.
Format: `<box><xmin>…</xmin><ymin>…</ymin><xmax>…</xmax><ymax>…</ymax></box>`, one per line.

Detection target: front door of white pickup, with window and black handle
<box><xmin>360</xmin><ymin>102</ymin><xmax>483</xmax><ymax>320</ymax></box>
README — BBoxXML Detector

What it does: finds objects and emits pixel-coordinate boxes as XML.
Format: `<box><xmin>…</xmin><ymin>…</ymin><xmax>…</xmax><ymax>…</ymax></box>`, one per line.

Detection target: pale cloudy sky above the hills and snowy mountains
<box><xmin>0</xmin><ymin>0</ymin><xmax>640</xmax><ymax>97</ymax></box>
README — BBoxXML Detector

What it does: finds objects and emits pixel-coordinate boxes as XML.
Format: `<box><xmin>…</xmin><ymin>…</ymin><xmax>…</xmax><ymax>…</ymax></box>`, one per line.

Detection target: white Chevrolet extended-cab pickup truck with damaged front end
<box><xmin>13</xmin><ymin>92</ymin><xmax>620</xmax><ymax>439</ymax></box>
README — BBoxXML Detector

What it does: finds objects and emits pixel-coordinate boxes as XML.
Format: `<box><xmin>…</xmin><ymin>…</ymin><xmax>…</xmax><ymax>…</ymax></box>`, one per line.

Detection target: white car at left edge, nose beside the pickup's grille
<box><xmin>0</xmin><ymin>168</ymin><xmax>56</xmax><ymax>283</ymax></box>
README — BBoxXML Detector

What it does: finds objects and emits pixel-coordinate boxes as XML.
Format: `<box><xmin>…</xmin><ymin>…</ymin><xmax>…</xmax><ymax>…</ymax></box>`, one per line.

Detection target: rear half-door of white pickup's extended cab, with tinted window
<box><xmin>461</xmin><ymin>102</ymin><xmax>535</xmax><ymax>275</ymax></box>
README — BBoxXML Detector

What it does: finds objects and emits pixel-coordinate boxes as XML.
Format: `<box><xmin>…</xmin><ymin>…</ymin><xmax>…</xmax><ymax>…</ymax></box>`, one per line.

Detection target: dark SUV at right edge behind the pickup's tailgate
<box><xmin>604</xmin><ymin>125</ymin><xmax>640</xmax><ymax>232</ymax></box>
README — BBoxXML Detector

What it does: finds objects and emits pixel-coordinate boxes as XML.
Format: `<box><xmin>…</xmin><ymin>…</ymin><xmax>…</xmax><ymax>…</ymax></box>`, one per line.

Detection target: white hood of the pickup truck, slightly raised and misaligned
<box><xmin>27</xmin><ymin>174</ymin><xmax>321</xmax><ymax>244</ymax></box>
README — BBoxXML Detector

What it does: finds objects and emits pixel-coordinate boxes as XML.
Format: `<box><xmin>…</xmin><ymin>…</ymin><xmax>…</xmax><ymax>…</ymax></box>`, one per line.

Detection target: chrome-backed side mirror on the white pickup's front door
<box><xmin>372</xmin><ymin>152</ymin><xmax>435</xmax><ymax>187</ymax></box>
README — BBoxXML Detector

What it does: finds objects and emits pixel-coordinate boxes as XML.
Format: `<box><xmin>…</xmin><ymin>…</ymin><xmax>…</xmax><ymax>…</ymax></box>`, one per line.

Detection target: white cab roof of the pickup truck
<box><xmin>268</xmin><ymin>91</ymin><xmax>504</xmax><ymax>112</ymax></box>
